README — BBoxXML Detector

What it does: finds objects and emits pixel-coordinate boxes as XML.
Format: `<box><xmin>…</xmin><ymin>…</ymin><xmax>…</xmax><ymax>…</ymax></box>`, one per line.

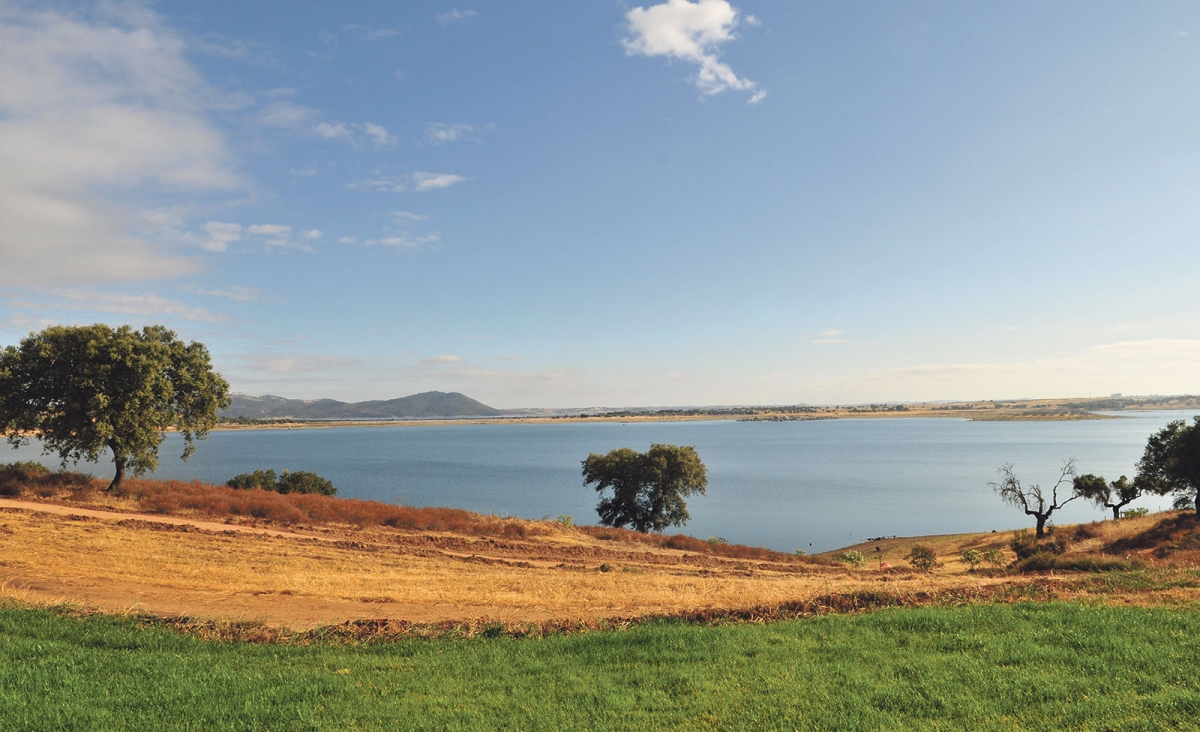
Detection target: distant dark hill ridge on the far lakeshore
<box><xmin>221</xmin><ymin>391</ymin><xmax>503</xmax><ymax>419</ymax></box>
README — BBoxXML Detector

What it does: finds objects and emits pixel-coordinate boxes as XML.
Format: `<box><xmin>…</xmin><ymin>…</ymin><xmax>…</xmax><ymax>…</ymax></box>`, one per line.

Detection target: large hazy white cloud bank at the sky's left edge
<box><xmin>0</xmin><ymin>4</ymin><xmax>245</xmax><ymax>286</ymax></box>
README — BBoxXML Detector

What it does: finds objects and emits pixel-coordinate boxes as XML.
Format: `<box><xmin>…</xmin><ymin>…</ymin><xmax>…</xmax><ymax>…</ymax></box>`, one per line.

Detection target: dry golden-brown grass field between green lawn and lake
<box><xmin>0</xmin><ymin>468</ymin><xmax>1200</xmax><ymax>629</ymax></box>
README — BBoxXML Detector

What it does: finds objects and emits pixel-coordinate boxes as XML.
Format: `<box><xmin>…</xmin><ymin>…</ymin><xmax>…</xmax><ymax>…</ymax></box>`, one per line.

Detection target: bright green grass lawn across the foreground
<box><xmin>0</xmin><ymin>604</ymin><xmax>1200</xmax><ymax>730</ymax></box>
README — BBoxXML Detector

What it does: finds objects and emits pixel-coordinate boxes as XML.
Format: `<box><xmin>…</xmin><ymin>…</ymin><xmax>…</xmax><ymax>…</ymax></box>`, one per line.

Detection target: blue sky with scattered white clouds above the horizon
<box><xmin>0</xmin><ymin>0</ymin><xmax>1200</xmax><ymax>408</ymax></box>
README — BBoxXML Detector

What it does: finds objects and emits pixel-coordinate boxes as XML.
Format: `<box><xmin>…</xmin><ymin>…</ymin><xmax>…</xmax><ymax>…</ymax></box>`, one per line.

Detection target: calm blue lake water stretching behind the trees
<box><xmin>7</xmin><ymin>412</ymin><xmax>1193</xmax><ymax>551</ymax></box>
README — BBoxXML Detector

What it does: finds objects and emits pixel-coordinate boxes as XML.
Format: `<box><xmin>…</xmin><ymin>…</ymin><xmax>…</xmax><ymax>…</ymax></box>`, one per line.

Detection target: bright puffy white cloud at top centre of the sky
<box><xmin>623</xmin><ymin>0</ymin><xmax>767</xmax><ymax>104</ymax></box>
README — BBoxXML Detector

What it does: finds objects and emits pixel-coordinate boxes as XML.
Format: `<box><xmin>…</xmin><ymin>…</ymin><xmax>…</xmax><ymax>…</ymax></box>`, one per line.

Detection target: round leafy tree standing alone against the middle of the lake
<box><xmin>583</xmin><ymin>444</ymin><xmax>708</xmax><ymax>532</ymax></box>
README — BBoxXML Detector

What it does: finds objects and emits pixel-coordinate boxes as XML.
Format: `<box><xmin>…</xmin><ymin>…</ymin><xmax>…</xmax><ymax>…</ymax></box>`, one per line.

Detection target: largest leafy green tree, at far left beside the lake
<box><xmin>0</xmin><ymin>323</ymin><xmax>229</xmax><ymax>491</ymax></box>
